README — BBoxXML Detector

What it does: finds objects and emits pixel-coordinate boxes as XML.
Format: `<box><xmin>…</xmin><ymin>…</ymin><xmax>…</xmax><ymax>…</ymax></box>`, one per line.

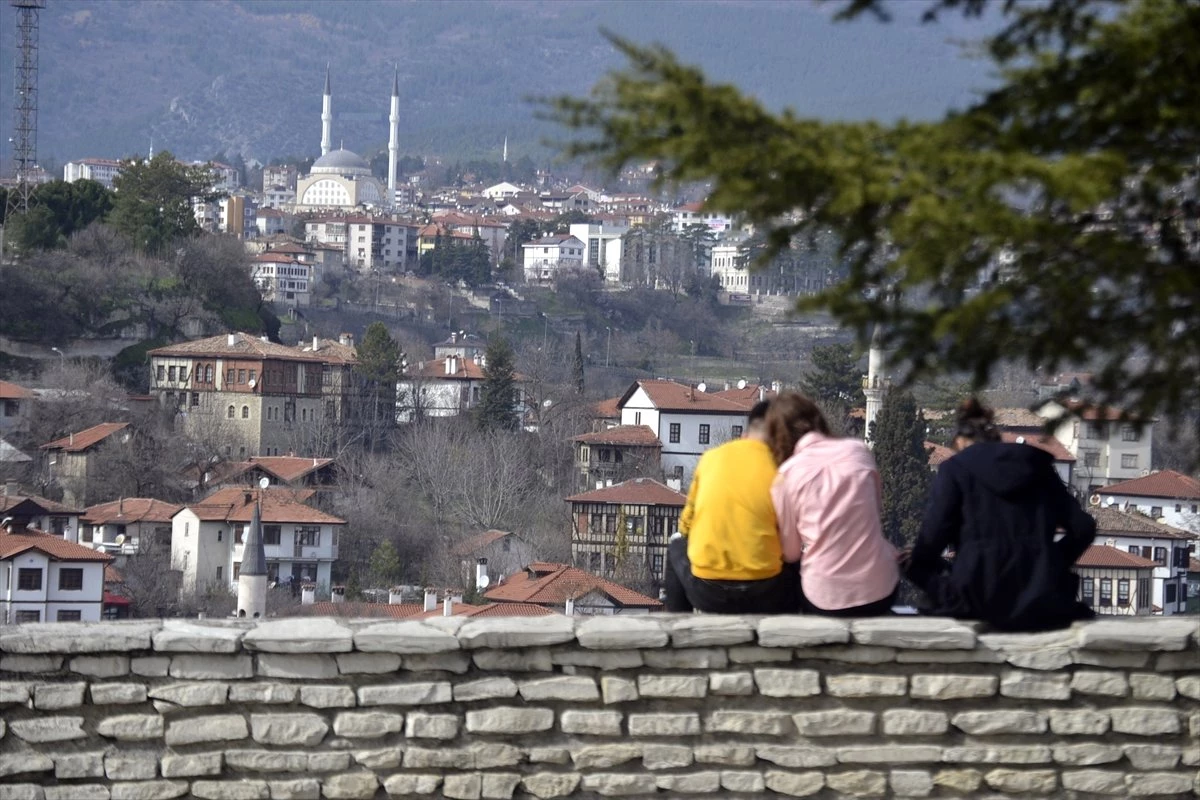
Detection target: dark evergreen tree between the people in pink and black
<box><xmin>871</xmin><ymin>390</ymin><xmax>932</xmax><ymax>547</ymax></box>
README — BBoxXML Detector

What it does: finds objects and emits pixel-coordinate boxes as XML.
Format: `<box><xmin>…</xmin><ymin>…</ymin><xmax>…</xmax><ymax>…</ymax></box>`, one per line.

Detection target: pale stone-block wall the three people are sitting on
<box><xmin>0</xmin><ymin>615</ymin><xmax>1200</xmax><ymax>800</ymax></box>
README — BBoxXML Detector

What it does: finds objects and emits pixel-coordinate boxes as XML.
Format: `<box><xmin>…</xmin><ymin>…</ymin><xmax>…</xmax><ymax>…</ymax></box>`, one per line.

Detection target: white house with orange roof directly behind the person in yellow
<box><xmin>617</xmin><ymin>380</ymin><xmax>754</xmax><ymax>491</ymax></box>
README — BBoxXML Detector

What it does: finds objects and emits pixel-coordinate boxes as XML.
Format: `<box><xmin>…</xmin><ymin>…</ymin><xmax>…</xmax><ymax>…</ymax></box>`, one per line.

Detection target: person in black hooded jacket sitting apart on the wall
<box><xmin>900</xmin><ymin>397</ymin><xmax>1096</xmax><ymax>631</ymax></box>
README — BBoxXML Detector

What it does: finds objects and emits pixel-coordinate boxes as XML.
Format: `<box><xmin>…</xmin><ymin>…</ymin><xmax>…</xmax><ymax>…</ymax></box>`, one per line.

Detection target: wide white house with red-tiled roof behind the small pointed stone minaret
<box><xmin>170</xmin><ymin>487</ymin><xmax>346</xmax><ymax>604</ymax></box>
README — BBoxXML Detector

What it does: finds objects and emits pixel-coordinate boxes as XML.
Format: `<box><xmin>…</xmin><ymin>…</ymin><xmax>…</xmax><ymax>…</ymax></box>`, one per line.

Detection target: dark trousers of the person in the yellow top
<box><xmin>666</xmin><ymin>536</ymin><xmax>799</xmax><ymax>614</ymax></box>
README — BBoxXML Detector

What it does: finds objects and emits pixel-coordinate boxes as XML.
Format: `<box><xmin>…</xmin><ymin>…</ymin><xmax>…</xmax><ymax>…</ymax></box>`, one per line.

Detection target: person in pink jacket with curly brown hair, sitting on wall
<box><xmin>767</xmin><ymin>392</ymin><xmax>900</xmax><ymax>616</ymax></box>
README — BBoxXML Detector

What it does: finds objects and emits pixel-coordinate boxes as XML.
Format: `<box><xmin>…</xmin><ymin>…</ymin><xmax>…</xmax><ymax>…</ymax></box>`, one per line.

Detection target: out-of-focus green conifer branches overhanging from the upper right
<box><xmin>547</xmin><ymin>0</ymin><xmax>1200</xmax><ymax>424</ymax></box>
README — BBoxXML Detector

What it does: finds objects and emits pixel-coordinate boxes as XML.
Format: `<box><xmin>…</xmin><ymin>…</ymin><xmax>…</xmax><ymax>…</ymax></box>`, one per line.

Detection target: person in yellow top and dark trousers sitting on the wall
<box><xmin>665</xmin><ymin>401</ymin><xmax>799</xmax><ymax>614</ymax></box>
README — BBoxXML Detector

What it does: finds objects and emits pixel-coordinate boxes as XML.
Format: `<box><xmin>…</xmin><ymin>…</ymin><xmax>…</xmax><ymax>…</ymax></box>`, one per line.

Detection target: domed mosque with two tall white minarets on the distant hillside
<box><xmin>295</xmin><ymin>67</ymin><xmax>400</xmax><ymax>211</ymax></box>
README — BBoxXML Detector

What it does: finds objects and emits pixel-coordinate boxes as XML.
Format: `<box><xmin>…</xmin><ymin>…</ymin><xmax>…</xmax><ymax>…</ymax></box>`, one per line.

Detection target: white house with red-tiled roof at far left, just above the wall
<box><xmin>0</xmin><ymin>524</ymin><xmax>113</xmax><ymax>624</ymax></box>
